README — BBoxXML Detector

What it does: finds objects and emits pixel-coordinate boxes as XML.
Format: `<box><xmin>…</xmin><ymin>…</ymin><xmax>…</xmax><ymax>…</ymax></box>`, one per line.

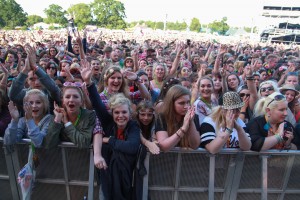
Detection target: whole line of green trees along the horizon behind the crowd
<box><xmin>0</xmin><ymin>0</ymin><xmax>253</xmax><ymax>35</ymax></box>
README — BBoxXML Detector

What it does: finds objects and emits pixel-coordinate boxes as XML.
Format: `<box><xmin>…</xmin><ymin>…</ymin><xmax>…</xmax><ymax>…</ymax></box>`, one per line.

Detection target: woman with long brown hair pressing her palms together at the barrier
<box><xmin>155</xmin><ymin>85</ymin><xmax>200</xmax><ymax>151</ymax></box>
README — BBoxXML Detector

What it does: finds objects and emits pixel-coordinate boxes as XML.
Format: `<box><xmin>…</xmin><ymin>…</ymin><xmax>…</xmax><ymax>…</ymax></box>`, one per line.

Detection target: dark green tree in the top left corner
<box><xmin>0</xmin><ymin>0</ymin><xmax>27</xmax><ymax>29</ymax></box>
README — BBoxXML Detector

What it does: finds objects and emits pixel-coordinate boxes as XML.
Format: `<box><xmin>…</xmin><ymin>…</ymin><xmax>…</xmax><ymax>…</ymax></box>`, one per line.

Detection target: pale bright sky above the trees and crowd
<box><xmin>16</xmin><ymin>0</ymin><xmax>262</xmax><ymax>27</ymax></box>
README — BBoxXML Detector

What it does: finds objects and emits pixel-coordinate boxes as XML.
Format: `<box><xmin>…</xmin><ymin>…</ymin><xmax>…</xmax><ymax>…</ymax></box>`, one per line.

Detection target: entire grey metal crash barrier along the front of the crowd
<box><xmin>0</xmin><ymin>138</ymin><xmax>300</xmax><ymax>200</ymax></box>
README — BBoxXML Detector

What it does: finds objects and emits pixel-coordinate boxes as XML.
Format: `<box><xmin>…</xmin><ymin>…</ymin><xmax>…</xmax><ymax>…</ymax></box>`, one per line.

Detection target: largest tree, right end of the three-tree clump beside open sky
<box><xmin>91</xmin><ymin>0</ymin><xmax>126</xmax><ymax>29</ymax></box>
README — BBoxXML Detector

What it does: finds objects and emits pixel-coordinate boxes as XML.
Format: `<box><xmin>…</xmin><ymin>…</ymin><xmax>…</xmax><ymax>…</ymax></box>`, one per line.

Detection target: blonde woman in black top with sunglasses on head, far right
<box><xmin>247</xmin><ymin>92</ymin><xmax>300</xmax><ymax>151</ymax></box>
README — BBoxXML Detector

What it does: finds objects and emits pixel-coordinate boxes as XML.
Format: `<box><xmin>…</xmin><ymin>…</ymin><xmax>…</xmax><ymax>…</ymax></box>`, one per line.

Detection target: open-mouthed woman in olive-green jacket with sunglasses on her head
<box><xmin>44</xmin><ymin>82</ymin><xmax>96</xmax><ymax>148</ymax></box>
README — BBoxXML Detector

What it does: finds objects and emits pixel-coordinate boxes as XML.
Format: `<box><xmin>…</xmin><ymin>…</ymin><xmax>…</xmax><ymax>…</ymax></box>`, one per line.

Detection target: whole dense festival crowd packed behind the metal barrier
<box><xmin>0</xmin><ymin>30</ymin><xmax>300</xmax><ymax>200</ymax></box>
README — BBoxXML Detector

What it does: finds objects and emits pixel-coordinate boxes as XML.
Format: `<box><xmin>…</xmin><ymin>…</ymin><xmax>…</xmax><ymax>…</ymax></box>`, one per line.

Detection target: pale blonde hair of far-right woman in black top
<box><xmin>254</xmin><ymin>92</ymin><xmax>286</xmax><ymax>117</ymax></box>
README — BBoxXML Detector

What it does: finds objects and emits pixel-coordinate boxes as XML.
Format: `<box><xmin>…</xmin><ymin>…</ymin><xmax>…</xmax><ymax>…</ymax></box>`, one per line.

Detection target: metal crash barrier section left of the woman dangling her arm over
<box><xmin>0</xmin><ymin>138</ymin><xmax>99</xmax><ymax>200</ymax></box>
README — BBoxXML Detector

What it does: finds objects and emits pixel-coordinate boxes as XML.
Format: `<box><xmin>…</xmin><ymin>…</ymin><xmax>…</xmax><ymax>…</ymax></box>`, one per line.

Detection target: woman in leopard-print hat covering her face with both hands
<box><xmin>200</xmin><ymin>92</ymin><xmax>251</xmax><ymax>154</ymax></box>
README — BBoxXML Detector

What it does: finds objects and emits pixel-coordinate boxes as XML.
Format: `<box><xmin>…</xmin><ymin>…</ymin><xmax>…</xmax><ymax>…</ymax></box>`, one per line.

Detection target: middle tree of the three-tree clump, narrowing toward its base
<box><xmin>68</xmin><ymin>3</ymin><xmax>93</xmax><ymax>29</ymax></box>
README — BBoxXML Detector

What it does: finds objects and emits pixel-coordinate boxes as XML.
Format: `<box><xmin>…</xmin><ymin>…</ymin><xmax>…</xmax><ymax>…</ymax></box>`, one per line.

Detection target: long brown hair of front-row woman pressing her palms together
<box><xmin>160</xmin><ymin>85</ymin><xmax>191</xmax><ymax>147</ymax></box>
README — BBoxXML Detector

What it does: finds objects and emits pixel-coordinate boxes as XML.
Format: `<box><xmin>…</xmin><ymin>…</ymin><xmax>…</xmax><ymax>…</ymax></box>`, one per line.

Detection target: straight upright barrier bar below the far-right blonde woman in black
<box><xmin>261</xmin><ymin>155</ymin><xmax>269</xmax><ymax>200</ymax></box>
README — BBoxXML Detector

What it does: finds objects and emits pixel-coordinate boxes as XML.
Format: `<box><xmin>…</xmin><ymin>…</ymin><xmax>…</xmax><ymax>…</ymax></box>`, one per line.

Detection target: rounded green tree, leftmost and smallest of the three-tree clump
<box><xmin>44</xmin><ymin>4</ymin><xmax>68</xmax><ymax>25</ymax></box>
